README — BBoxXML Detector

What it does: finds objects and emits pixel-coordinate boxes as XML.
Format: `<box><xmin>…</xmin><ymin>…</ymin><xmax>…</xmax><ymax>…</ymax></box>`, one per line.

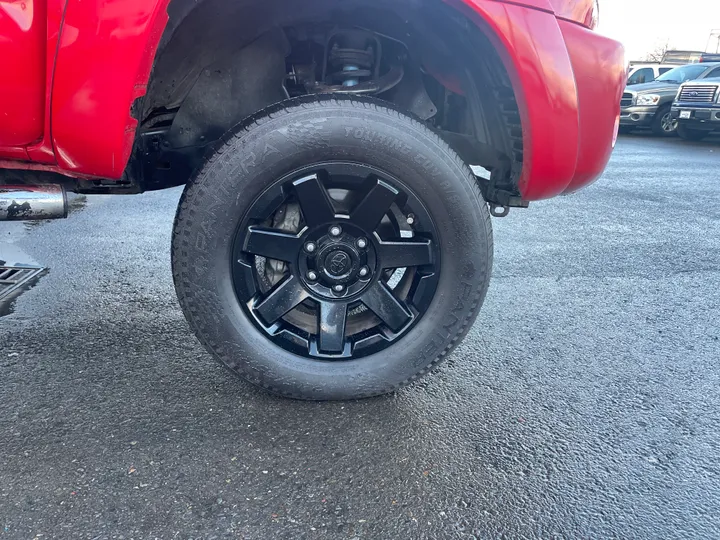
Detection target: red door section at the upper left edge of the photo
<box><xmin>0</xmin><ymin>0</ymin><xmax>47</xmax><ymax>147</ymax></box>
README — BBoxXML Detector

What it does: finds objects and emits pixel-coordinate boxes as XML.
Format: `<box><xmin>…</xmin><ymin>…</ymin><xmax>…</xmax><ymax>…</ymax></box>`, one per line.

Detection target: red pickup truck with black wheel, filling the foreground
<box><xmin>0</xmin><ymin>0</ymin><xmax>625</xmax><ymax>399</ymax></box>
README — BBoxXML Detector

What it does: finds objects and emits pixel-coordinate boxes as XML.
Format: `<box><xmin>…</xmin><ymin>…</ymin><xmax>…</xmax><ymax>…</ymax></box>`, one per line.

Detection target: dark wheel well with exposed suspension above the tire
<box><xmin>129</xmin><ymin>0</ymin><xmax>523</xmax><ymax>206</ymax></box>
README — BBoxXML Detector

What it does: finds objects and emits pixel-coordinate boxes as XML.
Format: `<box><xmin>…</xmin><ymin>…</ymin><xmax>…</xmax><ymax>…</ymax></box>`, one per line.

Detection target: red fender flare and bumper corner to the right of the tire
<box><xmin>453</xmin><ymin>0</ymin><xmax>625</xmax><ymax>200</ymax></box>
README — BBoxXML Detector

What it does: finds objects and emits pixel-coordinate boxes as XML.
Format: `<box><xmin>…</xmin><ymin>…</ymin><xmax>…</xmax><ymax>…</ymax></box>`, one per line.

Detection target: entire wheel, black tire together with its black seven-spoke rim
<box><xmin>172</xmin><ymin>96</ymin><xmax>493</xmax><ymax>400</ymax></box>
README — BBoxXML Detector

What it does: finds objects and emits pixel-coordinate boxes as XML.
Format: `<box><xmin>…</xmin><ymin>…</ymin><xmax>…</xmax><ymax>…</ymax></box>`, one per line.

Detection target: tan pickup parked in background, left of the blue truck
<box><xmin>620</xmin><ymin>62</ymin><xmax>720</xmax><ymax>137</ymax></box>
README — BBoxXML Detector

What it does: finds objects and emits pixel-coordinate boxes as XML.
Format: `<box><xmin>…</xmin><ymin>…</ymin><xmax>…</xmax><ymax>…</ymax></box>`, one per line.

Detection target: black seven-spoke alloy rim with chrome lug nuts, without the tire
<box><xmin>232</xmin><ymin>163</ymin><xmax>441</xmax><ymax>360</ymax></box>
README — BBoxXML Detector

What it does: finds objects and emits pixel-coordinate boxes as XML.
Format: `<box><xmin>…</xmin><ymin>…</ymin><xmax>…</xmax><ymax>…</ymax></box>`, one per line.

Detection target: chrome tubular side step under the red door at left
<box><xmin>0</xmin><ymin>184</ymin><xmax>68</xmax><ymax>221</ymax></box>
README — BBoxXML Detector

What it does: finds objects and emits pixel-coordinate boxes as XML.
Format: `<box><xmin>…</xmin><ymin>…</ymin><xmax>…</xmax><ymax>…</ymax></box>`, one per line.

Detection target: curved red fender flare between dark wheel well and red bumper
<box><xmin>452</xmin><ymin>0</ymin><xmax>579</xmax><ymax>200</ymax></box>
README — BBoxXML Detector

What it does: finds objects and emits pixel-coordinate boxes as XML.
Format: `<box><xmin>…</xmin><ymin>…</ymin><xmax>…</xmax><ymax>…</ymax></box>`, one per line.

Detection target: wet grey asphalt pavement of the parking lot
<box><xmin>0</xmin><ymin>135</ymin><xmax>720</xmax><ymax>539</ymax></box>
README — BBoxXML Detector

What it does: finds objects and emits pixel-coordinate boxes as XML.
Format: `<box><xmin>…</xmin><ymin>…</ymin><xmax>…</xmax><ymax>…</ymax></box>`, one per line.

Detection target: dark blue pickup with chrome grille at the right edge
<box><xmin>672</xmin><ymin>77</ymin><xmax>720</xmax><ymax>141</ymax></box>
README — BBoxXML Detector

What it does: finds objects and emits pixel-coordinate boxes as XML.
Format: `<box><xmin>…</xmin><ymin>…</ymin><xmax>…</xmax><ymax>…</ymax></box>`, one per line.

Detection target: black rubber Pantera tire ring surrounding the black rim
<box><xmin>173</xmin><ymin>100</ymin><xmax>492</xmax><ymax>399</ymax></box>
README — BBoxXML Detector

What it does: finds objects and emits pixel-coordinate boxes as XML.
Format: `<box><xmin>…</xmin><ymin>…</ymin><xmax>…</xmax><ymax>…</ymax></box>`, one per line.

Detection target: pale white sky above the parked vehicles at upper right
<box><xmin>599</xmin><ymin>0</ymin><xmax>720</xmax><ymax>60</ymax></box>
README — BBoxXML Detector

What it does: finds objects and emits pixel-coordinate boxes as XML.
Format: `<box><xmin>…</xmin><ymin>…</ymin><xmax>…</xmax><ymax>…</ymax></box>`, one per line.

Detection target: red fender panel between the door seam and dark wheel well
<box><xmin>52</xmin><ymin>0</ymin><xmax>168</xmax><ymax>178</ymax></box>
